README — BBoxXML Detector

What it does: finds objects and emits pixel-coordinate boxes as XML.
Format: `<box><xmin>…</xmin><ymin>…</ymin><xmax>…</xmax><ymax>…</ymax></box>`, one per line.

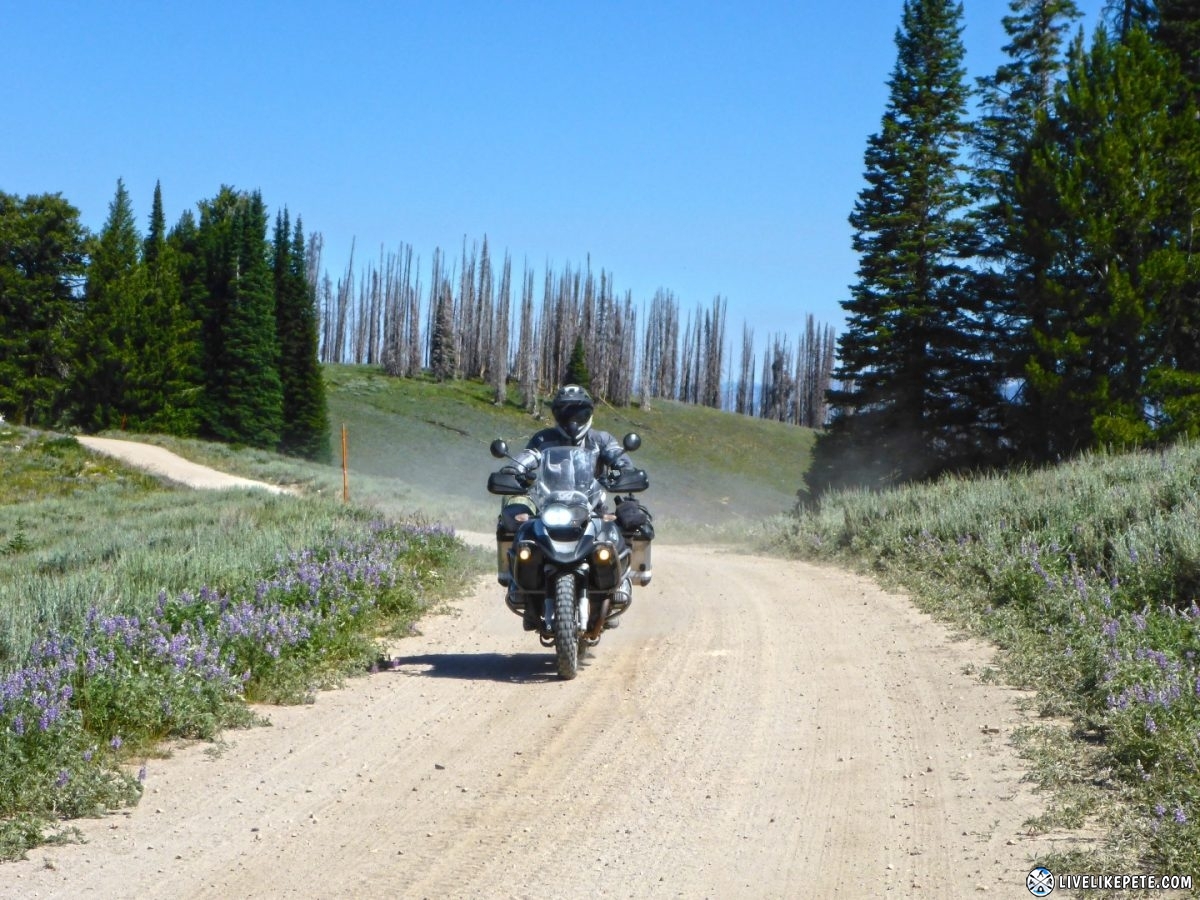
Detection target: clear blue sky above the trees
<box><xmin>0</xmin><ymin>0</ymin><xmax>1103</xmax><ymax>360</ymax></box>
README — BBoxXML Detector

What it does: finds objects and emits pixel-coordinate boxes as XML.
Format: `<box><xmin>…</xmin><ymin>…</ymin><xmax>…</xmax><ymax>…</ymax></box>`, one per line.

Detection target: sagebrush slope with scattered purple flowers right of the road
<box><xmin>774</xmin><ymin>443</ymin><xmax>1200</xmax><ymax>875</ymax></box>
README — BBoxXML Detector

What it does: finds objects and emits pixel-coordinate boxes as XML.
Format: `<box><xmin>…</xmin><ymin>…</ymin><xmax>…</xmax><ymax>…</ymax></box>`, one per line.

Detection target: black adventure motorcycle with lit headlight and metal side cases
<box><xmin>487</xmin><ymin>434</ymin><xmax>654</xmax><ymax>679</ymax></box>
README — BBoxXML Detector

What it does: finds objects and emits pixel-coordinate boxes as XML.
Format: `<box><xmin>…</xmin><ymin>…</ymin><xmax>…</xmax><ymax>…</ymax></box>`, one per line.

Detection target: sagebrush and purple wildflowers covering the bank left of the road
<box><xmin>0</xmin><ymin>424</ymin><xmax>478</xmax><ymax>859</ymax></box>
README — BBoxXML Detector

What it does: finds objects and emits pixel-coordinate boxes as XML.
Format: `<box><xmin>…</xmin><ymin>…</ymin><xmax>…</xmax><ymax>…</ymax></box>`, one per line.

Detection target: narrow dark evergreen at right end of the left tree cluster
<box><xmin>274</xmin><ymin>210</ymin><xmax>331</xmax><ymax>462</ymax></box>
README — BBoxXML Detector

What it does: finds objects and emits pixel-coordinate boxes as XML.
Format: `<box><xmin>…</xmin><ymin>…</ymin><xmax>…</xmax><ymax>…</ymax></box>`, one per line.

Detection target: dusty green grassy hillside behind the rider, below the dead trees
<box><xmin>326</xmin><ymin>366</ymin><xmax>814</xmax><ymax>539</ymax></box>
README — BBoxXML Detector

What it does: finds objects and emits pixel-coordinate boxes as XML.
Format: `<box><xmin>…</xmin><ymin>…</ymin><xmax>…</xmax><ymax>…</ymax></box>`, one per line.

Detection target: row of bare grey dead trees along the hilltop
<box><xmin>308</xmin><ymin>235</ymin><xmax>835</xmax><ymax>427</ymax></box>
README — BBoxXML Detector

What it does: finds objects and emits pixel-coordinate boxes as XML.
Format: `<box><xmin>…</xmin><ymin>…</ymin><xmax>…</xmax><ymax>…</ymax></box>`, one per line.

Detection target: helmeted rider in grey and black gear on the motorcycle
<box><xmin>500</xmin><ymin>384</ymin><xmax>644</xmax><ymax>631</ymax></box>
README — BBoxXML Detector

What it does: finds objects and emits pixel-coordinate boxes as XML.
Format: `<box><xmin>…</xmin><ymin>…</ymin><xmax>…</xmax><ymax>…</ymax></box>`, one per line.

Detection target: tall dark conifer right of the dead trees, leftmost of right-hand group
<box><xmin>809</xmin><ymin>0</ymin><xmax>1000</xmax><ymax>493</ymax></box>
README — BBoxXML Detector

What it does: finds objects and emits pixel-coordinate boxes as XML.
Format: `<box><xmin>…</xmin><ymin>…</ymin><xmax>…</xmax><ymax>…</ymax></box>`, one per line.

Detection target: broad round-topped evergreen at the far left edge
<box><xmin>0</xmin><ymin>191</ymin><xmax>85</xmax><ymax>426</ymax></box>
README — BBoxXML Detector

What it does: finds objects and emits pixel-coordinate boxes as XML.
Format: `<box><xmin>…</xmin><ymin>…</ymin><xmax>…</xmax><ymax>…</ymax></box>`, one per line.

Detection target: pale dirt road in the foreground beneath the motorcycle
<box><xmin>0</xmin><ymin>441</ymin><xmax>1039</xmax><ymax>900</ymax></box>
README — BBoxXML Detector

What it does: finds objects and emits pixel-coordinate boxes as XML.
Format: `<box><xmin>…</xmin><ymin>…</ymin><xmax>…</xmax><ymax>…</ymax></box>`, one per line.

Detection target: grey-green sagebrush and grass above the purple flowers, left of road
<box><xmin>0</xmin><ymin>430</ymin><xmax>451</xmax><ymax>666</ymax></box>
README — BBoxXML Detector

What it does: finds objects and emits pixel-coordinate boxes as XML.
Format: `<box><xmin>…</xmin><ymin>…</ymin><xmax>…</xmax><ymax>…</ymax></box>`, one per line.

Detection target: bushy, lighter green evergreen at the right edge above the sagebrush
<box><xmin>1019</xmin><ymin>29</ymin><xmax>1200</xmax><ymax>458</ymax></box>
